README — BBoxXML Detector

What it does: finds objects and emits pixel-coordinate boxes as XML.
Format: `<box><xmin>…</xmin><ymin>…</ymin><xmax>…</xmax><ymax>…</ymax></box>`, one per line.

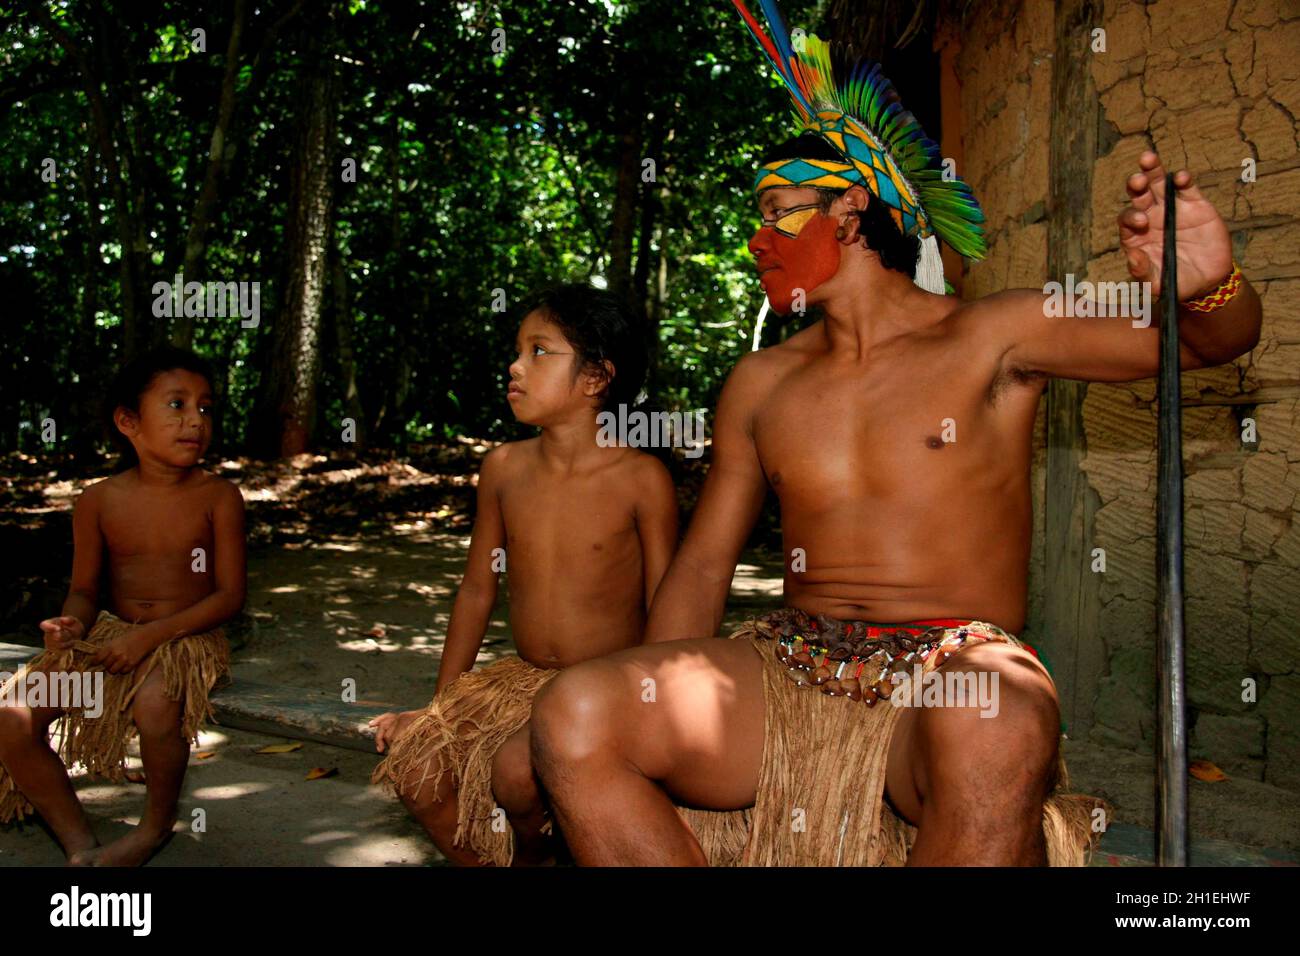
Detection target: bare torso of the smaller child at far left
<box><xmin>98</xmin><ymin>471</ymin><xmax>226</xmax><ymax>623</ymax></box>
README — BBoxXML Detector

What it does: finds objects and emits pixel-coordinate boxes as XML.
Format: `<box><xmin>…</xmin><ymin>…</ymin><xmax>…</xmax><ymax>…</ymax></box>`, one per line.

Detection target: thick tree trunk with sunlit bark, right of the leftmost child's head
<box><xmin>259</xmin><ymin>14</ymin><xmax>335</xmax><ymax>458</ymax></box>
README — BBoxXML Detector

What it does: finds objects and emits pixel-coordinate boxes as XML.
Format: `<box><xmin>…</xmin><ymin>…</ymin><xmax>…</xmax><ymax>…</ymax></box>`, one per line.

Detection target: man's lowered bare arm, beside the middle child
<box><xmin>645</xmin><ymin>354</ymin><xmax>770</xmax><ymax>644</ymax></box>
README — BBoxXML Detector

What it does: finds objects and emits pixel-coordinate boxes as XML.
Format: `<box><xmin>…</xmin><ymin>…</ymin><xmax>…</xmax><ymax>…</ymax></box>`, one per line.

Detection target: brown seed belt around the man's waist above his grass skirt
<box><xmin>754</xmin><ymin>607</ymin><xmax>1017</xmax><ymax>705</ymax></box>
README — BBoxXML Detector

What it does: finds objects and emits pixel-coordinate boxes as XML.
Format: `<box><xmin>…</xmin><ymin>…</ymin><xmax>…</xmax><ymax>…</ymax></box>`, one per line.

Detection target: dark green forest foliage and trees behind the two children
<box><xmin>0</xmin><ymin>0</ymin><xmax>930</xmax><ymax>457</ymax></box>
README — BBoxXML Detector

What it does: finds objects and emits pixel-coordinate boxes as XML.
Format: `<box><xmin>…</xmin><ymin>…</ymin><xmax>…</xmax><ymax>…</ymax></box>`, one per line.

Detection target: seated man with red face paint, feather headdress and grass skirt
<box><xmin>532</xmin><ymin>0</ymin><xmax>1260</xmax><ymax>865</ymax></box>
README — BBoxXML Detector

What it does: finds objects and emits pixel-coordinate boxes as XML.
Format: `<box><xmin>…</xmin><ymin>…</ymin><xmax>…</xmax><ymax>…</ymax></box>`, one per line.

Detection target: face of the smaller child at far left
<box><xmin>113</xmin><ymin>368</ymin><xmax>212</xmax><ymax>468</ymax></box>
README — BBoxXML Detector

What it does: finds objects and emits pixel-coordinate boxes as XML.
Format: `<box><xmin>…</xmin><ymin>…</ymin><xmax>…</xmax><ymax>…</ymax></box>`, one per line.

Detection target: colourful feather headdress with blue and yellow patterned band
<box><xmin>732</xmin><ymin>0</ymin><xmax>988</xmax><ymax>294</ymax></box>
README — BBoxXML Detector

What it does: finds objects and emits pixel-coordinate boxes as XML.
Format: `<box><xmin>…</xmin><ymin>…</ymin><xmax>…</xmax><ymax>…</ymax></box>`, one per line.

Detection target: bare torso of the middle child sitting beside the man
<box><xmin>501</xmin><ymin>441</ymin><xmax>646</xmax><ymax>667</ymax></box>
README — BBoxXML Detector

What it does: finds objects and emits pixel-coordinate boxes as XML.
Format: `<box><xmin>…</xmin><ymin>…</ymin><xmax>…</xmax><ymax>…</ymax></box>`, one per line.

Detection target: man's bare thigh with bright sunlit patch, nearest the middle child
<box><xmin>553</xmin><ymin>639</ymin><xmax>763</xmax><ymax>810</ymax></box>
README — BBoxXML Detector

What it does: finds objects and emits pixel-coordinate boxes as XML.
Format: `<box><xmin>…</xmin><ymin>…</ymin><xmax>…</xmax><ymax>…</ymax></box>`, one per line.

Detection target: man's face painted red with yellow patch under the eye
<box><xmin>749</xmin><ymin>193</ymin><xmax>840</xmax><ymax>315</ymax></box>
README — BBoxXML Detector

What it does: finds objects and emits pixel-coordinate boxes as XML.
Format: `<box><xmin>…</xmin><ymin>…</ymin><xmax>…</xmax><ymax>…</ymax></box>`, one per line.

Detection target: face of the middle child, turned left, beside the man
<box><xmin>506</xmin><ymin>311</ymin><xmax>599</xmax><ymax>425</ymax></box>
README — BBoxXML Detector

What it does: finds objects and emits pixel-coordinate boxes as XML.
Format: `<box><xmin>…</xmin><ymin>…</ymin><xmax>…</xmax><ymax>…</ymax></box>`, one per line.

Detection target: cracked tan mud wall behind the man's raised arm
<box><xmin>944</xmin><ymin>0</ymin><xmax>1300</xmax><ymax>788</ymax></box>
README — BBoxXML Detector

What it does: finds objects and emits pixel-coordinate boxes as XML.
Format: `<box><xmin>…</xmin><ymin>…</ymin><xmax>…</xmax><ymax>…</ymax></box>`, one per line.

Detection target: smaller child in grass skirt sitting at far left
<box><xmin>0</xmin><ymin>349</ymin><xmax>244</xmax><ymax>866</ymax></box>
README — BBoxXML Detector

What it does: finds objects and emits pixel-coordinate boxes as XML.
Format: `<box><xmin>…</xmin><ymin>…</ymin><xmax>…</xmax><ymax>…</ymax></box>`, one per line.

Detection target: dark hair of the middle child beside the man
<box><xmin>519</xmin><ymin>284</ymin><xmax>649</xmax><ymax>410</ymax></box>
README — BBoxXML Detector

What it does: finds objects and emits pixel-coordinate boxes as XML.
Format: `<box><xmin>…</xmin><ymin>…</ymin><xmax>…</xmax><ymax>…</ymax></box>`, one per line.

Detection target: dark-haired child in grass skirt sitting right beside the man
<box><xmin>372</xmin><ymin>285</ymin><xmax>677</xmax><ymax>865</ymax></box>
